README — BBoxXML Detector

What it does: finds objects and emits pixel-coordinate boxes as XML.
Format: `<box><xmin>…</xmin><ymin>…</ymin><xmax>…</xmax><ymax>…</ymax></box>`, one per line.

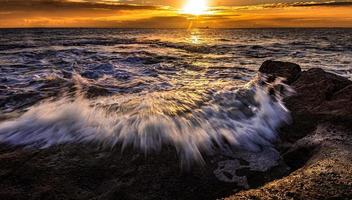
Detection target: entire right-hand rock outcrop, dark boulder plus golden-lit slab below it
<box><xmin>226</xmin><ymin>61</ymin><xmax>352</xmax><ymax>200</ymax></box>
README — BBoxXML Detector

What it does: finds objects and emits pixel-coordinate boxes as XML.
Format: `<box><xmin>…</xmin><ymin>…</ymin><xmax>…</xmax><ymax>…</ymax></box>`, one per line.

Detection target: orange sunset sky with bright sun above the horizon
<box><xmin>0</xmin><ymin>0</ymin><xmax>352</xmax><ymax>28</ymax></box>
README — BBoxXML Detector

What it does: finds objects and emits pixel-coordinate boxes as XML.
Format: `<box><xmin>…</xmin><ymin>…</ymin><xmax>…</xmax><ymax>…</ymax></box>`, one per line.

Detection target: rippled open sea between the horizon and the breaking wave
<box><xmin>0</xmin><ymin>29</ymin><xmax>352</xmax><ymax>97</ymax></box>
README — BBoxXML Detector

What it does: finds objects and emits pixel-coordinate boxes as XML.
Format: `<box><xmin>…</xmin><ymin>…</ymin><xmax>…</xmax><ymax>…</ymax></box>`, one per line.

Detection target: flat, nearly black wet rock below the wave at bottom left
<box><xmin>0</xmin><ymin>144</ymin><xmax>236</xmax><ymax>200</ymax></box>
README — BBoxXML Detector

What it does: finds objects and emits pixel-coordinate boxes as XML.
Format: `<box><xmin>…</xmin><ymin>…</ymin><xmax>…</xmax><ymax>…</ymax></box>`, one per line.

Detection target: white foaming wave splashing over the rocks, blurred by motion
<box><xmin>0</xmin><ymin>75</ymin><xmax>290</xmax><ymax>164</ymax></box>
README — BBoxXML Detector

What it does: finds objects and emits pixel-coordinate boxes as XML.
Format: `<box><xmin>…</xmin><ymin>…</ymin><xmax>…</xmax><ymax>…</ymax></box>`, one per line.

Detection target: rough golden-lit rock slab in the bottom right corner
<box><xmin>226</xmin><ymin>124</ymin><xmax>352</xmax><ymax>200</ymax></box>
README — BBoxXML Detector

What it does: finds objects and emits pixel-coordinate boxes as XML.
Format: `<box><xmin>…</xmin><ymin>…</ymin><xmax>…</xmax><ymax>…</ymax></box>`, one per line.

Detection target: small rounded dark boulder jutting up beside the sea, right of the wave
<box><xmin>259</xmin><ymin>60</ymin><xmax>301</xmax><ymax>84</ymax></box>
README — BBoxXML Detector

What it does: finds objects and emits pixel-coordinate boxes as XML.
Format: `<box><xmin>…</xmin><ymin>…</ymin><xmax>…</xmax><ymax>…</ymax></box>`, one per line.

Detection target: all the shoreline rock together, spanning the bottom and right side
<box><xmin>0</xmin><ymin>61</ymin><xmax>352</xmax><ymax>200</ymax></box>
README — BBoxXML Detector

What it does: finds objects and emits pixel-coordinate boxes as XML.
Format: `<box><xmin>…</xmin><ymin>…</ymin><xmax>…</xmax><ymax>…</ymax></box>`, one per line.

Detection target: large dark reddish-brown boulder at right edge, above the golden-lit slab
<box><xmin>281</xmin><ymin>68</ymin><xmax>352</xmax><ymax>142</ymax></box>
